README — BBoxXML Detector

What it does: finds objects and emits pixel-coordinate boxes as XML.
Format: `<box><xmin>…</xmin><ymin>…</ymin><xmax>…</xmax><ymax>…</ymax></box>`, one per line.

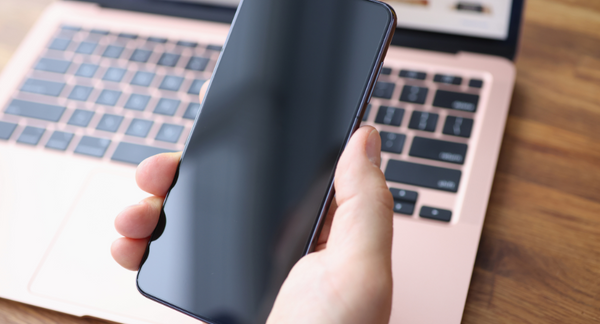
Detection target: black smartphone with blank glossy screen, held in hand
<box><xmin>137</xmin><ymin>0</ymin><xmax>396</xmax><ymax>324</ymax></box>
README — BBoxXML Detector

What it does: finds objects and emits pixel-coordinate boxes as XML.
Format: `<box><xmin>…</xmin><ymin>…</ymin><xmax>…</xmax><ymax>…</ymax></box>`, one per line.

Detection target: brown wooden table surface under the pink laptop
<box><xmin>0</xmin><ymin>0</ymin><xmax>600</xmax><ymax>324</ymax></box>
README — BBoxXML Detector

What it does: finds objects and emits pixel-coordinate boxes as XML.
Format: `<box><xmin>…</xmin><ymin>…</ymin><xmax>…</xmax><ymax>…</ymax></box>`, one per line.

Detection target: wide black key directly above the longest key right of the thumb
<box><xmin>408</xmin><ymin>136</ymin><xmax>467</xmax><ymax>164</ymax></box>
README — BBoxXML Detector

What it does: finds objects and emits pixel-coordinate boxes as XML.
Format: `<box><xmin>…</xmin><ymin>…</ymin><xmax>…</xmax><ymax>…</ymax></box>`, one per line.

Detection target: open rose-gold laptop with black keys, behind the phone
<box><xmin>0</xmin><ymin>0</ymin><xmax>523</xmax><ymax>324</ymax></box>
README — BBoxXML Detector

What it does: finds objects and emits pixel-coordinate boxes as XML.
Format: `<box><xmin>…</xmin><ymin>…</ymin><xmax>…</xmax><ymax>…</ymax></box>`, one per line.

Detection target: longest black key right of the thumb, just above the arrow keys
<box><xmin>385</xmin><ymin>160</ymin><xmax>462</xmax><ymax>192</ymax></box>
